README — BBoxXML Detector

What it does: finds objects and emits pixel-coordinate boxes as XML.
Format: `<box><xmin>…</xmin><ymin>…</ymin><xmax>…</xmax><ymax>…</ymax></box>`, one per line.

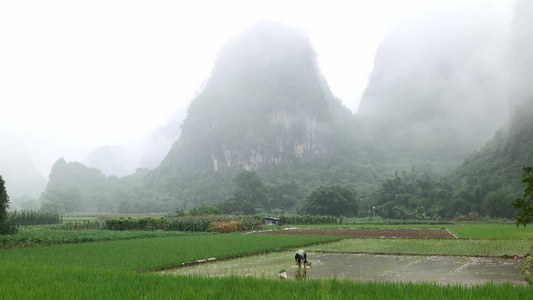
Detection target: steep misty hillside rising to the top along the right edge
<box><xmin>446</xmin><ymin>1</ymin><xmax>533</xmax><ymax>209</ymax></box>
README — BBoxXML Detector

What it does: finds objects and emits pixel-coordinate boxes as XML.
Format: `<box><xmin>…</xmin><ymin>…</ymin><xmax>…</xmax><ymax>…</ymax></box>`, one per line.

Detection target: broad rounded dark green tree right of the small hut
<box><xmin>303</xmin><ymin>184</ymin><xmax>359</xmax><ymax>217</ymax></box>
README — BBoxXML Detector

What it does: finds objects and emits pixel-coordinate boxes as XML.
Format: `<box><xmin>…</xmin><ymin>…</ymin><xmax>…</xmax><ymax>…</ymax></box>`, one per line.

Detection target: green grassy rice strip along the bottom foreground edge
<box><xmin>0</xmin><ymin>262</ymin><xmax>533</xmax><ymax>300</ymax></box>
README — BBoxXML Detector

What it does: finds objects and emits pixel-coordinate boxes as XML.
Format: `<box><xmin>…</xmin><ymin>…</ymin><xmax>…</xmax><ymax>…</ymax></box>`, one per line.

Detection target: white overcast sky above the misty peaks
<box><xmin>0</xmin><ymin>0</ymin><xmax>514</xmax><ymax>176</ymax></box>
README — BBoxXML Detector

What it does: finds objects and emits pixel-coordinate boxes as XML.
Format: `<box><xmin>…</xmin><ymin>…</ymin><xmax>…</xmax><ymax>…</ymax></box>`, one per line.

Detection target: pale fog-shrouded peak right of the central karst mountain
<box><xmin>357</xmin><ymin>3</ymin><xmax>509</xmax><ymax>164</ymax></box>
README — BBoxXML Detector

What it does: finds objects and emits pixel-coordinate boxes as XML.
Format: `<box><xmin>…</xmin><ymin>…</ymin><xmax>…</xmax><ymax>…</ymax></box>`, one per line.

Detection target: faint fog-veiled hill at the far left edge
<box><xmin>0</xmin><ymin>132</ymin><xmax>46</xmax><ymax>200</ymax></box>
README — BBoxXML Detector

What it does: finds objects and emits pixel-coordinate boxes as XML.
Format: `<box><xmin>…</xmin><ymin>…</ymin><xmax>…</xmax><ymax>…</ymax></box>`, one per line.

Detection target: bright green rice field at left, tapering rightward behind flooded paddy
<box><xmin>0</xmin><ymin>234</ymin><xmax>340</xmax><ymax>271</ymax></box>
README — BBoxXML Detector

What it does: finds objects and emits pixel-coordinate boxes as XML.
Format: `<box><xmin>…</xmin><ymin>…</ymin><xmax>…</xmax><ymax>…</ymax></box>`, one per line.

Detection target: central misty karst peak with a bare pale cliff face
<box><xmin>142</xmin><ymin>22</ymin><xmax>387</xmax><ymax>209</ymax></box>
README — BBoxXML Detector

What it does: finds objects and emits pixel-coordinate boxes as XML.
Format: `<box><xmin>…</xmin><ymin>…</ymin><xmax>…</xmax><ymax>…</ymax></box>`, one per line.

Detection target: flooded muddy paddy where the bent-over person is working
<box><xmin>163</xmin><ymin>251</ymin><xmax>526</xmax><ymax>285</ymax></box>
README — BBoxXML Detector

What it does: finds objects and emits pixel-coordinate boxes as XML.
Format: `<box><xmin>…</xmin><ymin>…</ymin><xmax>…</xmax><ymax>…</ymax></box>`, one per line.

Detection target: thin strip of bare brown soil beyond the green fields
<box><xmin>255</xmin><ymin>228</ymin><xmax>455</xmax><ymax>239</ymax></box>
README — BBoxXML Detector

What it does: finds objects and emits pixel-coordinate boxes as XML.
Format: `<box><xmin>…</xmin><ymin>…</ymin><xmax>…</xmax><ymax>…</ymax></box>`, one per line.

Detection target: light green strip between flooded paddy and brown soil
<box><xmin>307</xmin><ymin>239</ymin><xmax>533</xmax><ymax>256</ymax></box>
